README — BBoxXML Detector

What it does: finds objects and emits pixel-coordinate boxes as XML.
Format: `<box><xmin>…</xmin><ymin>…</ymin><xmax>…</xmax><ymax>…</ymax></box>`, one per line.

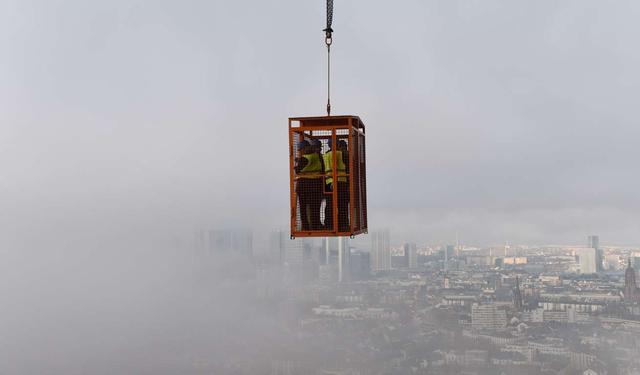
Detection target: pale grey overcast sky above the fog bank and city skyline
<box><xmin>0</xmin><ymin>0</ymin><xmax>640</xmax><ymax>250</ymax></box>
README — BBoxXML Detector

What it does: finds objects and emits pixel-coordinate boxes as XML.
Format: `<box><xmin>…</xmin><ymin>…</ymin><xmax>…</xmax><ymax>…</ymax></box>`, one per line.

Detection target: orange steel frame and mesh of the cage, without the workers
<box><xmin>289</xmin><ymin>115</ymin><xmax>368</xmax><ymax>238</ymax></box>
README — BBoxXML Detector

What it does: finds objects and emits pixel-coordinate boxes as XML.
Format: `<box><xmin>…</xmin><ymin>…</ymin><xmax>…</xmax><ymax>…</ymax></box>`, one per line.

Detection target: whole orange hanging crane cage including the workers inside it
<box><xmin>289</xmin><ymin>116</ymin><xmax>367</xmax><ymax>238</ymax></box>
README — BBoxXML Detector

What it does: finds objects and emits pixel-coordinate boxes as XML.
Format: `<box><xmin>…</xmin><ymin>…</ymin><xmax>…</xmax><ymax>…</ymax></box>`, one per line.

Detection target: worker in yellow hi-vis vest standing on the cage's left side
<box><xmin>295</xmin><ymin>140</ymin><xmax>323</xmax><ymax>231</ymax></box>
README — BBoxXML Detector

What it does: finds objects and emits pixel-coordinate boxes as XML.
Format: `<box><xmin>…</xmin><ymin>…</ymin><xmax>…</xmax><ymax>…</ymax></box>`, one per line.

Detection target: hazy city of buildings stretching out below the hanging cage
<box><xmin>188</xmin><ymin>230</ymin><xmax>640</xmax><ymax>375</ymax></box>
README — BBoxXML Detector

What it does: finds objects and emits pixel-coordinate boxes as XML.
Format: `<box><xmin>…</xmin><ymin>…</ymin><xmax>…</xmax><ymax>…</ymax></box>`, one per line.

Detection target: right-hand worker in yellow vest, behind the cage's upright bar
<box><xmin>323</xmin><ymin>140</ymin><xmax>349</xmax><ymax>232</ymax></box>
